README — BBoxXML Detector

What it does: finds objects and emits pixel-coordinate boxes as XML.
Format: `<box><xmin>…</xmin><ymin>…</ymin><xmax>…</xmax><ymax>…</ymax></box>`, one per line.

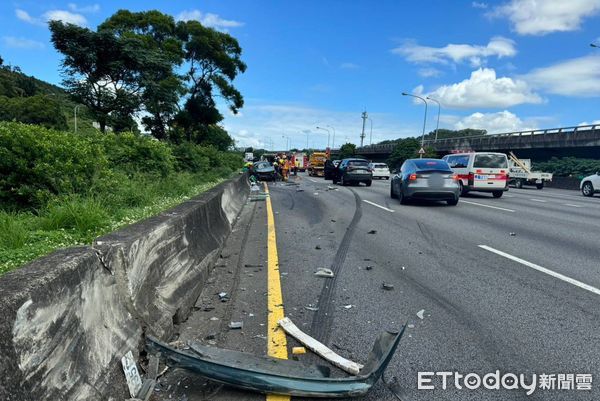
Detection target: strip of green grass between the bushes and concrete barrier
<box><xmin>0</xmin><ymin>169</ymin><xmax>231</xmax><ymax>275</ymax></box>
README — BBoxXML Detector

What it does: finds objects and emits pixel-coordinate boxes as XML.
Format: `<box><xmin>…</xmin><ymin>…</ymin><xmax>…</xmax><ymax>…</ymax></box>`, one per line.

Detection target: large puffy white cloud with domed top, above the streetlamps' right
<box><xmin>415</xmin><ymin>68</ymin><xmax>542</xmax><ymax>108</ymax></box>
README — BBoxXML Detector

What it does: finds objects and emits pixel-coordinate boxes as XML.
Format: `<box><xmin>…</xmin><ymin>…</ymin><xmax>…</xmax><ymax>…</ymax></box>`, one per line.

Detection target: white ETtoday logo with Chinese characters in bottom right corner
<box><xmin>417</xmin><ymin>370</ymin><xmax>592</xmax><ymax>395</ymax></box>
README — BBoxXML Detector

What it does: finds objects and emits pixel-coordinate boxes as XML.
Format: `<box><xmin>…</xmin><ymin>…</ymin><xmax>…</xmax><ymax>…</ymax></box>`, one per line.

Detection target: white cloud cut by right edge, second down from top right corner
<box><xmin>521</xmin><ymin>55</ymin><xmax>600</xmax><ymax>97</ymax></box>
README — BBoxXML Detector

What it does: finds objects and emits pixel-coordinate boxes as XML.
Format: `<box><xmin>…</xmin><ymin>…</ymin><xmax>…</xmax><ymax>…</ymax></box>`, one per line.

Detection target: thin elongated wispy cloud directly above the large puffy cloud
<box><xmin>392</xmin><ymin>36</ymin><xmax>517</xmax><ymax>67</ymax></box>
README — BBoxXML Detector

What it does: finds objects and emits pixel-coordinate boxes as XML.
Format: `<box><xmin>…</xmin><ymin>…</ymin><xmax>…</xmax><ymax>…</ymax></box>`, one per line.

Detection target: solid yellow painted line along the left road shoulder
<box><xmin>264</xmin><ymin>183</ymin><xmax>290</xmax><ymax>401</ymax></box>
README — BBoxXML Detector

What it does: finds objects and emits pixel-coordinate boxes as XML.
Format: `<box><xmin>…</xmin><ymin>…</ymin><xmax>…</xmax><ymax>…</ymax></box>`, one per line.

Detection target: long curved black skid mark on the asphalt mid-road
<box><xmin>311</xmin><ymin>189</ymin><xmax>362</xmax><ymax>343</ymax></box>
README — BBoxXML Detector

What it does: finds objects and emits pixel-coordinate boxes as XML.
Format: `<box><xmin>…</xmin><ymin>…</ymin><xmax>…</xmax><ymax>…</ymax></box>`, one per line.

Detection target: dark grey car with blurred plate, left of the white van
<box><xmin>390</xmin><ymin>159</ymin><xmax>460</xmax><ymax>206</ymax></box>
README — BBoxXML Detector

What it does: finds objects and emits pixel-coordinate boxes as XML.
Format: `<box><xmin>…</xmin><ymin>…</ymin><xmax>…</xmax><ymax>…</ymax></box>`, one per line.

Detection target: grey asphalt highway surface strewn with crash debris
<box><xmin>157</xmin><ymin>175</ymin><xmax>600</xmax><ymax>401</ymax></box>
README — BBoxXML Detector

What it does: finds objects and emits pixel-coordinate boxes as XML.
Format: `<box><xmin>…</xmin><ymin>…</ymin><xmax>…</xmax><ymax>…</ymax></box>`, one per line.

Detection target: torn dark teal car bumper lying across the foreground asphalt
<box><xmin>146</xmin><ymin>327</ymin><xmax>404</xmax><ymax>398</ymax></box>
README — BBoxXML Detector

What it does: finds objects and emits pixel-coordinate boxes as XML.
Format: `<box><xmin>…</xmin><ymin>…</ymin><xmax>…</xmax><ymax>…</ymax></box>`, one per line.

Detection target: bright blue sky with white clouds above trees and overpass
<box><xmin>0</xmin><ymin>0</ymin><xmax>600</xmax><ymax>148</ymax></box>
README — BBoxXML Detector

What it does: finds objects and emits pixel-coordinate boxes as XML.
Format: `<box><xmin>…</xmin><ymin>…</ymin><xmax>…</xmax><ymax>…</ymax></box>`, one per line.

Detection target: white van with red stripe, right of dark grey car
<box><xmin>442</xmin><ymin>152</ymin><xmax>508</xmax><ymax>198</ymax></box>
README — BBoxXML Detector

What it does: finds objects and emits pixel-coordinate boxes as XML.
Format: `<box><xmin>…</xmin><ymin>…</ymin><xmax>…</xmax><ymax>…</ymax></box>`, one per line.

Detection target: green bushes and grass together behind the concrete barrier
<box><xmin>0</xmin><ymin>122</ymin><xmax>242</xmax><ymax>274</ymax></box>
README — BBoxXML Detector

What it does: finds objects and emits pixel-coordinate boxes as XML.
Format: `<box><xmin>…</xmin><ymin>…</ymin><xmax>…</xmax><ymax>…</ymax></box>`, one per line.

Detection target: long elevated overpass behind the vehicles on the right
<box><xmin>356</xmin><ymin>124</ymin><xmax>600</xmax><ymax>161</ymax></box>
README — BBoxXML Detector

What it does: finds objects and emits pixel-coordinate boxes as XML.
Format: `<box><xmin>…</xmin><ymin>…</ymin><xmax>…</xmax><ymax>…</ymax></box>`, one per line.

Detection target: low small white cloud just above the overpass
<box><xmin>454</xmin><ymin>110</ymin><xmax>538</xmax><ymax>134</ymax></box>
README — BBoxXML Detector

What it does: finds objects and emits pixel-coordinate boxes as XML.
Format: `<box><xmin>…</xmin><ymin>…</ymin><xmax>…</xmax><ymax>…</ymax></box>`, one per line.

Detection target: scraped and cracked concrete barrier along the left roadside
<box><xmin>0</xmin><ymin>175</ymin><xmax>249</xmax><ymax>401</ymax></box>
